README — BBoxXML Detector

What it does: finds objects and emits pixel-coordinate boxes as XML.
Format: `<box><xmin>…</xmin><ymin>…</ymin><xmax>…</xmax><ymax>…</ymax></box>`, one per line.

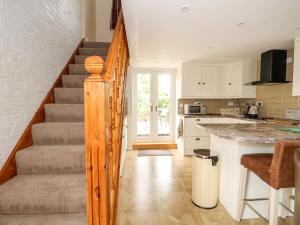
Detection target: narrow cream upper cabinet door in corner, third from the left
<box><xmin>220</xmin><ymin>65</ymin><xmax>233</xmax><ymax>97</ymax></box>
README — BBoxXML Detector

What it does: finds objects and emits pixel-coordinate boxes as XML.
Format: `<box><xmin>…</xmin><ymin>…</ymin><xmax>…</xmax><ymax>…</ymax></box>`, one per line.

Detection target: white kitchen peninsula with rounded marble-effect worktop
<box><xmin>202</xmin><ymin>123</ymin><xmax>300</xmax><ymax>221</ymax></box>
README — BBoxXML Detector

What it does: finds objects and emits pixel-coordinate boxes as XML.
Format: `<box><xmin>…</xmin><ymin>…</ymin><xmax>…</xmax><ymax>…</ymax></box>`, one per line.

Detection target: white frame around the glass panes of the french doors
<box><xmin>132</xmin><ymin>67</ymin><xmax>177</xmax><ymax>143</ymax></box>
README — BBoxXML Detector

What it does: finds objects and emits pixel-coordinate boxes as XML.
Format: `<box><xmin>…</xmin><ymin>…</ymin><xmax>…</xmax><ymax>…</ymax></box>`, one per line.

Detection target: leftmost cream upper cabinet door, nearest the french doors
<box><xmin>182</xmin><ymin>66</ymin><xmax>201</xmax><ymax>98</ymax></box>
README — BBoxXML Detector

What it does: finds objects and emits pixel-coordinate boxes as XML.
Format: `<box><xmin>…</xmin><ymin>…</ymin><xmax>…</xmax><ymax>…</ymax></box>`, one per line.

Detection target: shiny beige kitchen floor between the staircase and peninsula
<box><xmin>118</xmin><ymin>150</ymin><xmax>292</xmax><ymax>225</ymax></box>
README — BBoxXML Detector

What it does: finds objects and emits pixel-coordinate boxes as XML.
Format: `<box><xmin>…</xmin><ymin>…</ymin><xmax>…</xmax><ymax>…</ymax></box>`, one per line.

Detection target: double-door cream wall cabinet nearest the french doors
<box><xmin>182</xmin><ymin>66</ymin><xmax>219</xmax><ymax>98</ymax></box>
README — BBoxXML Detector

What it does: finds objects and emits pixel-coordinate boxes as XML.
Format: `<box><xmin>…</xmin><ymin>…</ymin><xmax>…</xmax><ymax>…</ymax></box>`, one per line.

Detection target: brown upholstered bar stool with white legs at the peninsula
<box><xmin>240</xmin><ymin>141</ymin><xmax>300</xmax><ymax>225</ymax></box>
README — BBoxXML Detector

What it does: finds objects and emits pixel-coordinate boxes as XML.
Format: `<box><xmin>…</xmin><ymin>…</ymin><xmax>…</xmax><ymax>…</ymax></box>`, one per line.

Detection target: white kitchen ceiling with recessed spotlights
<box><xmin>122</xmin><ymin>0</ymin><xmax>300</xmax><ymax>64</ymax></box>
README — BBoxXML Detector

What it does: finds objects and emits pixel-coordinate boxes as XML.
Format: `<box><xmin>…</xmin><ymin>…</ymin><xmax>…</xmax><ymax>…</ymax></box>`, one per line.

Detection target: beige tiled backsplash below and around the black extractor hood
<box><xmin>256</xmin><ymin>50</ymin><xmax>300</xmax><ymax>118</ymax></box>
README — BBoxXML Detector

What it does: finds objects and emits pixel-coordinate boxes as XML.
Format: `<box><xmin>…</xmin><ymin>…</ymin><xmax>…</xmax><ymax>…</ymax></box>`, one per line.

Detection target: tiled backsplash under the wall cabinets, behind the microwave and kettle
<box><xmin>178</xmin><ymin>99</ymin><xmax>250</xmax><ymax>114</ymax></box>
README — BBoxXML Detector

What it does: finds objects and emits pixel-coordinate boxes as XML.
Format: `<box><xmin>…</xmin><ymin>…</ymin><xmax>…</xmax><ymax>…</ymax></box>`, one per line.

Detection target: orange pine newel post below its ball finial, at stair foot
<box><xmin>84</xmin><ymin>75</ymin><xmax>111</xmax><ymax>225</ymax></box>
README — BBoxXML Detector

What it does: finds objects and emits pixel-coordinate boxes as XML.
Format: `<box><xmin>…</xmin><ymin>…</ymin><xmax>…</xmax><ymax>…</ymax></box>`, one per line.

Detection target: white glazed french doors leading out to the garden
<box><xmin>134</xmin><ymin>69</ymin><xmax>175</xmax><ymax>142</ymax></box>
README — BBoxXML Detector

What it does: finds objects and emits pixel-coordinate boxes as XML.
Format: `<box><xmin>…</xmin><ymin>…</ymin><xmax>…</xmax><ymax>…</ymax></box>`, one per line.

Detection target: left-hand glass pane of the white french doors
<box><xmin>136</xmin><ymin>73</ymin><xmax>152</xmax><ymax>138</ymax></box>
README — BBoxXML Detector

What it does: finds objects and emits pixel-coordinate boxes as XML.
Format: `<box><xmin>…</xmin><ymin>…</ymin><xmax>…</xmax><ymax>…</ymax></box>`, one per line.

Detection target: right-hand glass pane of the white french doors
<box><xmin>155</xmin><ymin>73</ymin><xmax>172</xmax><ymax>137</ymax></box>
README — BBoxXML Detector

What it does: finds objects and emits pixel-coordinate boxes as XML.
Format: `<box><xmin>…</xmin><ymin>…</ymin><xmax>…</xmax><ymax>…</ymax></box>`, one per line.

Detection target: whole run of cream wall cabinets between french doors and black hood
<box><xmin>182</xmin><ymin>60</ymin><xmax>256</xmax><ymax>98</ymax></box>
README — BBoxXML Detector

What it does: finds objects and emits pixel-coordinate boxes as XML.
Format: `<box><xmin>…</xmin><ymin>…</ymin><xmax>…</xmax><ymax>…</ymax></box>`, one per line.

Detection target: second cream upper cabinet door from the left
<box><xmin>201</xmin><ymin>66</ymin><xmax>220</xmax><ymax>97</ymax></box>
